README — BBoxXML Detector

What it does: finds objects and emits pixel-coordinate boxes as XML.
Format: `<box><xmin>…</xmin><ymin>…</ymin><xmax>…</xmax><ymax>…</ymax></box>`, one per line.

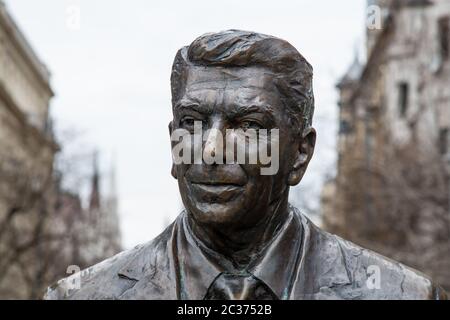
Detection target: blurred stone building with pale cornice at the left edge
<box><xmin>0</xmin><ymin>1</ymin><xmax>58</xmax><ymax>297</ymax></box>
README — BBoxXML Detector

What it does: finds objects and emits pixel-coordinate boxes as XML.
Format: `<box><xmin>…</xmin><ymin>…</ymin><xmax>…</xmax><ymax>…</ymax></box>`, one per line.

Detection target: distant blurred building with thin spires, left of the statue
<box><xmin>52</xmin><ymin>156</ymin><xmax>122</xmax><ymax>277</ymax></box>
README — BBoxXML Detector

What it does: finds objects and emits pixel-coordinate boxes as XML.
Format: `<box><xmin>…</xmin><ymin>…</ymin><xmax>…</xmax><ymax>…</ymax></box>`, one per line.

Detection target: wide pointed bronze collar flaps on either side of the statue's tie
<box><xmin>176</xmin><ymin>207</ymin><xmax>303</xmax><ymax>299</ymax></box>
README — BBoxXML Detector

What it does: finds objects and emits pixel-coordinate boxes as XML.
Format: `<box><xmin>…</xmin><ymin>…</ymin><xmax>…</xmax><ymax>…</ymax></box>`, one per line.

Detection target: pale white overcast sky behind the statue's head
<box><xmin>5</xmin><ymin>0</ymin><xmax>365</xmax><ymax>248</ymax></box>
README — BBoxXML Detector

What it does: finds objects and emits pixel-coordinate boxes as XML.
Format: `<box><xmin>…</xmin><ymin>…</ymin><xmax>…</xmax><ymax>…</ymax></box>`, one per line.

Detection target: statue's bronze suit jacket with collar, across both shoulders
<box><xmin>44</xmin><ymin>207</ymin><xmax>446</xmax><ymax>299</ymax></box>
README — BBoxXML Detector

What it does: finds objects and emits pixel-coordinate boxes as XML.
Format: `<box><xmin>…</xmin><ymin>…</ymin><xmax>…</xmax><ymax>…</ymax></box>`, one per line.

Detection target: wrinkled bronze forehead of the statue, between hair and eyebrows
<box><xmin>180</xmin><ymin>67</ymin><xmax>281</xmax><ymax>108</ymax></box>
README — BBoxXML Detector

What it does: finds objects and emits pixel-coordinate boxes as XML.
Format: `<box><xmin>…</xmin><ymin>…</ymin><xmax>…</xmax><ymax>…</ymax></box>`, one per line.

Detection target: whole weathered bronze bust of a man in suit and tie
<box><xmin>46</xmin><ymin>30</ymin><xmax>445</xmax><ymax>299</ymax></box>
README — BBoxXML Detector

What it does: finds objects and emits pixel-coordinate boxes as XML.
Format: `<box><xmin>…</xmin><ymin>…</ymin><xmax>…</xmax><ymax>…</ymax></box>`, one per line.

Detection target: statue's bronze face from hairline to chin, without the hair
<box><xmin>170</xmin><ymin>67</ymin><xmax>314</xmax><ymax>227</ymax></box>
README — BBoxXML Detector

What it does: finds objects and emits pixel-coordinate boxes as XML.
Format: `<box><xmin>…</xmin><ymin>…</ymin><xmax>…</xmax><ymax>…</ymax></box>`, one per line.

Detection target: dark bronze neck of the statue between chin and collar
<box><xmin>188</xmin><ymin>191</ymin><xmax>289</xmax><ymax>269</ymax></box>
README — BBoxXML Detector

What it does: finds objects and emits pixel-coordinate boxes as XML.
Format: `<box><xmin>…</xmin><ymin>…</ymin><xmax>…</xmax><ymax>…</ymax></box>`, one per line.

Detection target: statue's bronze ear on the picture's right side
<box><xmin>288</xmin><ymin>128</ymin><xmax>316</xmax><ymax>186</ymax></box>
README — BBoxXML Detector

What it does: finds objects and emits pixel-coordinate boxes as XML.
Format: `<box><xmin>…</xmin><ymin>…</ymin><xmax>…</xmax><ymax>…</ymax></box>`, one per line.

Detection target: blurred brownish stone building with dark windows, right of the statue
<box><xmin>322</xmin><ymin>0</ymin><xmax>450</xmax><ymax>288</ymax></box>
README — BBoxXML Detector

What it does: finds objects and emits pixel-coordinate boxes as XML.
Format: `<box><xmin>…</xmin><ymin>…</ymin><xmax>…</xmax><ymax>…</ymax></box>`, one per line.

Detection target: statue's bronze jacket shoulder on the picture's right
<box><xmin>298</xmin><ymin>211</ymin><xmax>446</xmax><ymax>300</ymax></box>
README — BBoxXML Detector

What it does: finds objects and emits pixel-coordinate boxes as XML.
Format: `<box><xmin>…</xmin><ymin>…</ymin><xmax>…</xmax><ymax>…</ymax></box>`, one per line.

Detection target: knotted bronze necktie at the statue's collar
<box><xmin>204</xmin><ymin>272</ymin><xmax>278</xmax><ymax>300</ymax></box>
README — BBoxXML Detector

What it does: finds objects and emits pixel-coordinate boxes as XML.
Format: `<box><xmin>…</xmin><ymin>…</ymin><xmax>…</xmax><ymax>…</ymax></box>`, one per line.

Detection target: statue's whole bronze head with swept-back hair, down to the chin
<box><xmin>169</xmin><ymin>30</ymin><xmax>316</xmax><ymax>228</ymax></box>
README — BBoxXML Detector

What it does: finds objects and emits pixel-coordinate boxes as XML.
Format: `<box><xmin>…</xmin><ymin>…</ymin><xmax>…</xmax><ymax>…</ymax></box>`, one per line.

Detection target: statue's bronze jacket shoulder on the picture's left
<box><xmin>44</xmin><ymin>221</ymin><xmax>172</xmax><ymax>300</ymax></box>
